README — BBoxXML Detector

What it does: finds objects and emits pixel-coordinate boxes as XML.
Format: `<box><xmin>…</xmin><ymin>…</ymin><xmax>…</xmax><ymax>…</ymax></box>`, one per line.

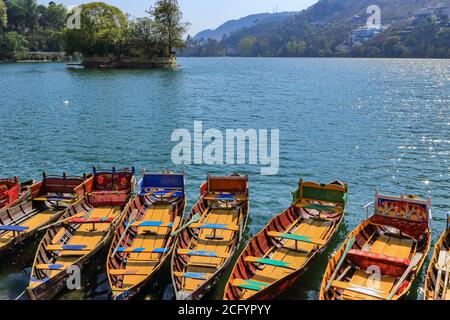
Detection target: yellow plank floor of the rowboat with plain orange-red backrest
<box><xmin>183</xmin><ymin>208</ymin><xmax>239</xmax><ymax>291</ymax></box>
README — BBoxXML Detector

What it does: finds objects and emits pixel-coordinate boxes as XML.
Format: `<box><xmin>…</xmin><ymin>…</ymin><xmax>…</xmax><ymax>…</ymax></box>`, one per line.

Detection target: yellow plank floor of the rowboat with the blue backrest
<box><xmin>117</xmin><ymin>204</ymin><xmax>171</xmax><ymax>289</ymax></box>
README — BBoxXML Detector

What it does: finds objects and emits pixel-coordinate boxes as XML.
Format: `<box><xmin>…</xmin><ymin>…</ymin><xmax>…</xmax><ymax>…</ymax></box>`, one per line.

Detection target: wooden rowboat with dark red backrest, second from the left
<box><xmin>0</xmin><ymin>173</ymin><xmax>86</xmax><ymax>254</ymax></box>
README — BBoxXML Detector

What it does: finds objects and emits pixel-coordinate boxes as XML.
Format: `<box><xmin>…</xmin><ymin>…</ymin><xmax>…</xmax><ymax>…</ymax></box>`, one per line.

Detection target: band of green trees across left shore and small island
<box><xmin>0</xmin><ymin>0</ymin><xmax>188</xmax><ymax>61</ymax></box>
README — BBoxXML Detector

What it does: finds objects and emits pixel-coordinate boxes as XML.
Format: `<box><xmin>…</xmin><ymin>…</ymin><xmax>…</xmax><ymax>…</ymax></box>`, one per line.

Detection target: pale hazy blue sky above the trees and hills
<box><xmin>38</xmin><ymin>0</ymin><xmax>317</xmax><ymax>35</ymax></box>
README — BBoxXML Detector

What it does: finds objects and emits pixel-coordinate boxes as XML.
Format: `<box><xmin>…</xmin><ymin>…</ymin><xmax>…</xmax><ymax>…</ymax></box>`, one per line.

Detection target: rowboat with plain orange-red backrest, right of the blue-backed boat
<box><xmin>171</xmin><ymin>175</ymin><xmax>249</xmax><ymax>300</ymax></box>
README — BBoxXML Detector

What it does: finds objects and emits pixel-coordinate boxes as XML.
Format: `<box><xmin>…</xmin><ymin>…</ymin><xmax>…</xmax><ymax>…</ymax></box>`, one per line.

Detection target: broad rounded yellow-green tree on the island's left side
<box><xmin>65</xmin><ymin>2</ymin><xmax>127</xmax><ymax>55</ymax></box>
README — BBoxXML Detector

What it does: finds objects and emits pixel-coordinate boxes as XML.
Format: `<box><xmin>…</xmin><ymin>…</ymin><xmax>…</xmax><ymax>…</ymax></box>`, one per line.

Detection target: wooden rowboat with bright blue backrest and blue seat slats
<box><xmin>107</xmin><ymin>173</ymin><xmax>186</xmax><ymax>300</ymax></box>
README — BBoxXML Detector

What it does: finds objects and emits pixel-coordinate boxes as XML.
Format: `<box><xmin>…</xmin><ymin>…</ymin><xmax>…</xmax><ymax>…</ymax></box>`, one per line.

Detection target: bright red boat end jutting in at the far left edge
<box><xmin>0</xmin><ymin>177</ymin><xmax>34</xmax><ymax>209</ymax></box>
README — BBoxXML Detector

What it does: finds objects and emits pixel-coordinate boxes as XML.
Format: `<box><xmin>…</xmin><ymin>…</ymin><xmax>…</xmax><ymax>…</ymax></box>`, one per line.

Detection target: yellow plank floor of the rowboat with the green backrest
<box><xmin>241</xmin><ymin>218</ymin><xmax>333</xmax><ymax>299</ymax></box>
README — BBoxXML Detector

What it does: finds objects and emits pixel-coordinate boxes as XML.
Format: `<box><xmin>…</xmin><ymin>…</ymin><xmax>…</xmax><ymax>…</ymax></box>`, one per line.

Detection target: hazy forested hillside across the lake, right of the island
<box><xmin>185</xmin><ymin>0</ymin><xmax>450</xmax><ymax>58</ymax></box>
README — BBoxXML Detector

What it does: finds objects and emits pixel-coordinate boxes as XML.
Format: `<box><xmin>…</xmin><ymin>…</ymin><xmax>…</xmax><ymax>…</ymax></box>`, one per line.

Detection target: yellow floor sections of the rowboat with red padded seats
<box><xmin>342</xmin><ymin>234</ymin><xmax>414</xmax><ymax>300</ymax></box>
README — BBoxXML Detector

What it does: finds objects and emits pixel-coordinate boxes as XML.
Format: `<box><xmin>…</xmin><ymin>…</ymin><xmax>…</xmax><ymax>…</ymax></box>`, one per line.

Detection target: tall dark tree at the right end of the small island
<box><xmin>148</xmin><ymin>0</ymin><xmax>188</xmax><ymax>56</ymax></box>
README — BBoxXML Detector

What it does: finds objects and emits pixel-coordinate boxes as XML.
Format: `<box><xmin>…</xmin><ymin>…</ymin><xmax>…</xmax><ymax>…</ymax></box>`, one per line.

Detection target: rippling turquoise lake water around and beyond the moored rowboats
<box><xmin>0</xmin><ymin>58</ymin><xmax>450</xmax><ymax>299</ymax></box>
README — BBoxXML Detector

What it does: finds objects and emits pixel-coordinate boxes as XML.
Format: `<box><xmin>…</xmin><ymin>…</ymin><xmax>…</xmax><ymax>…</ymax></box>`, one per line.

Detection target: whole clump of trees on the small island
<box><xmin>65</xmin><ymin>0</ymin><xmax>187</xmax><ymax>58</ymax></box>
